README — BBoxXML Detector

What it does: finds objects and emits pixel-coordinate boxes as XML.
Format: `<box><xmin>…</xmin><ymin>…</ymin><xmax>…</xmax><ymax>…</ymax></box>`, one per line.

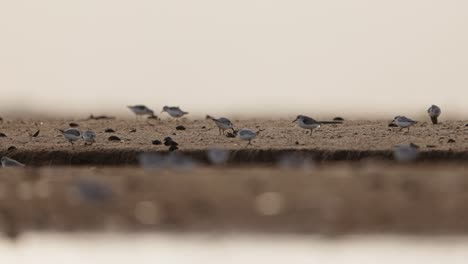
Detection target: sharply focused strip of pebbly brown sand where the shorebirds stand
<box><xmin>0</xmin><ymin>119</ymin><xmax>468</xmax><ymax>166</ymax></box>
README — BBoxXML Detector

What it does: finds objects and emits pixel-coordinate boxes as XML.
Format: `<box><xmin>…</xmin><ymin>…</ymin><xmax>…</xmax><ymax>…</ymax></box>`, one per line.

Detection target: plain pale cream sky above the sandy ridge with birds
<box><xmin>0</xmin><ymin>0</ymin><xmax>468</xmax><ymax>117</ymax></box>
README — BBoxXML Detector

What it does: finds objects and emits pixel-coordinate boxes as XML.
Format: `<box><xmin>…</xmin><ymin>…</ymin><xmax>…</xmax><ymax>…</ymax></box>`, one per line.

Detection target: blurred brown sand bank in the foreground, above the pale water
<box><xmin>0</xmin><ymin>165</ymin><xmax>468</xmax><ymax>238</ymax></box>
